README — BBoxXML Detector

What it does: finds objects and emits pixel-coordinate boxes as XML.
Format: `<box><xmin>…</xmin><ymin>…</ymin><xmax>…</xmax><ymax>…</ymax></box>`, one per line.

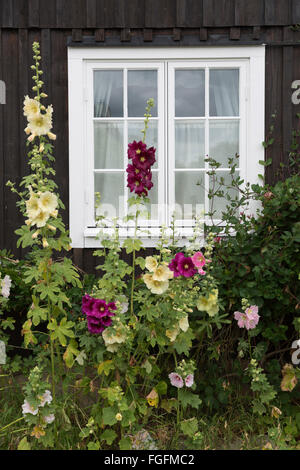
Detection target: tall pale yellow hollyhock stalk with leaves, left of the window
<box><xmin>7</xmin><ymin>42</ymin><xmax>81</xmax><ymax>398</ymax></box>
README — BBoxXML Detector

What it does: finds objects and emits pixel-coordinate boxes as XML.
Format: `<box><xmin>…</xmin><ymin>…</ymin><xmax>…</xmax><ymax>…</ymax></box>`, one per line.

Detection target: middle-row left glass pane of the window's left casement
<box><xmin>94</xmin><ymin>121</ymin><xmax>124</xmax><ymax>169</ymax></box>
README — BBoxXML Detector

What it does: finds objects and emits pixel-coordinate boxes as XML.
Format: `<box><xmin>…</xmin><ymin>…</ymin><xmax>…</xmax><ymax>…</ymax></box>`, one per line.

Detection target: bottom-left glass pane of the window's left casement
<box><xmin>95</xmin><ymin>172</ymin><xmax>124</xmax><ymax>219</ymax></box>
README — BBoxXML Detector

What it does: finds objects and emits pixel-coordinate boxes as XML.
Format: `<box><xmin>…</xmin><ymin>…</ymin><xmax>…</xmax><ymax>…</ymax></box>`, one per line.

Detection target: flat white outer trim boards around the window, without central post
<box><xmin>68</xmin><ymin>45</ymin><xmax>265</xmax><ymax>248</ymax></box>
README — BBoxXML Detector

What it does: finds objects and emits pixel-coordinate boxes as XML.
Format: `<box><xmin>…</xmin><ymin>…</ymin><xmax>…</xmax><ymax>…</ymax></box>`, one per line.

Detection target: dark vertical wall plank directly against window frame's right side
<box><xmin>265</xmin><ymin>28</ymin><xmax>283</xmax><ymax>184</ymax></box>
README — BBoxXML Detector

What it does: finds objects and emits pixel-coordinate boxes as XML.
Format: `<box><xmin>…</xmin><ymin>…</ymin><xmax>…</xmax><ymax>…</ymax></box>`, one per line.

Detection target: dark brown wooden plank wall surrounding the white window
<box><xmin>0</xmin><ymin>0</ymin><xmax>300</xmax><ymax>272</ymax></box>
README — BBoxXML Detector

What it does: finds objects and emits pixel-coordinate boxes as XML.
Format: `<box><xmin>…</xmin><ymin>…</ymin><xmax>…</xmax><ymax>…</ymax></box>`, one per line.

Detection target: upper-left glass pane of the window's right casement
<box><xmin>175</xmin><ymin>70</ymin><xmax>205</xmax><ymax>117</ymax></box>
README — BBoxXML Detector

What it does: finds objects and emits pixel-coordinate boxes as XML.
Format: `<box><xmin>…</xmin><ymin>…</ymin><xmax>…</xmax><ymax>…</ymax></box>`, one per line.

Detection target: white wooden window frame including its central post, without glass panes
<box><xmin>68</xmin><ymin>45</ymin><xmax>265</xmax><ymax>248</ymax></box>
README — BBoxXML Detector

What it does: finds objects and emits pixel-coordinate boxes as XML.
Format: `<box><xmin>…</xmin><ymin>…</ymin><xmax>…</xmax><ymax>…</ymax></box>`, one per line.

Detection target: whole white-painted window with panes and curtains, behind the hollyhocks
<box><xmin>68</xmin><ymin>46</ymin><xmax>265</xmax><ymax>248</ymax></box>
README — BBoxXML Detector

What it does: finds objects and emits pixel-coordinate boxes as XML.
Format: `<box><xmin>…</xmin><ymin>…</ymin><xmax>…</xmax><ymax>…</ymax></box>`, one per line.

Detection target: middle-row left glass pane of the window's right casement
<box><xmin>175</xmin><ymin>121</ymin><xmax>205</xmax><ymax>168</ymax></box>
